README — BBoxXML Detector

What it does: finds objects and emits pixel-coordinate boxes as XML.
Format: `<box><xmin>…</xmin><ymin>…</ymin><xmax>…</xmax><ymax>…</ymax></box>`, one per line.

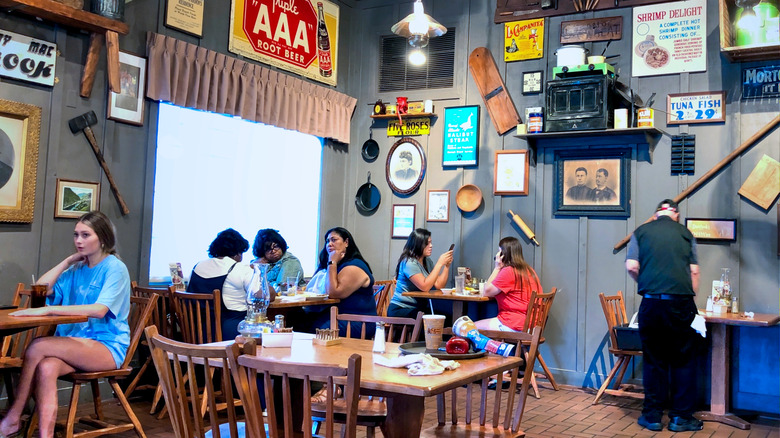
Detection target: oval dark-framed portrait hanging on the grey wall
<box><xmin>385</xmin><ymin>137</ymin><xmax>425</xmax><ymax>195</ymax></box>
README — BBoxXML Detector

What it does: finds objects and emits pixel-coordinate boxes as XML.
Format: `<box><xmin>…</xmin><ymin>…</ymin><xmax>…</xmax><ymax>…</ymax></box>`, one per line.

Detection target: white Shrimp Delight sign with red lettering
<box><xmin>631</xmin><ymin>0</ymin><xmax>707</xmax><ymax>77</ymax></box>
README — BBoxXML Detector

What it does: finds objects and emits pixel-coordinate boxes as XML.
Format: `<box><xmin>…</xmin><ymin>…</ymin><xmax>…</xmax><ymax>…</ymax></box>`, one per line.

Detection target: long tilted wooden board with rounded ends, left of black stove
<box><xmin>469</xmin><ymin>47</ymin><xmax>520</xmax><ymax>135</ymax></box>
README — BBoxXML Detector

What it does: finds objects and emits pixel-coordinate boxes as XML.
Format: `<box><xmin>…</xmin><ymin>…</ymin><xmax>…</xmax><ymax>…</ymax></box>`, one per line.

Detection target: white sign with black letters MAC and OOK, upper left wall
<box><xmin>0</xmin><ymin>29</ymin><xmax>57</xmax><ymax>87</ymax></box>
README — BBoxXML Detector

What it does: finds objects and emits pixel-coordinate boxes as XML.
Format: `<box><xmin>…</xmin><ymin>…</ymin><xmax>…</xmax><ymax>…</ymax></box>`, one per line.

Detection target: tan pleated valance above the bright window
<box><xmin>146</xmin><ymin>32</ymin><xmax>357</xmax><ymax>143</ymax></box>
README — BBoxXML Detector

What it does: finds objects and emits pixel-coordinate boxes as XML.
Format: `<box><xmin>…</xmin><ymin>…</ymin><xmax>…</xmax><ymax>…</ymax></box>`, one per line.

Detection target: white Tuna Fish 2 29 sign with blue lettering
<box><xmin>666</xmin><ymin>91</ymin><xmax>726</xmax><ymax>125</ymax></box>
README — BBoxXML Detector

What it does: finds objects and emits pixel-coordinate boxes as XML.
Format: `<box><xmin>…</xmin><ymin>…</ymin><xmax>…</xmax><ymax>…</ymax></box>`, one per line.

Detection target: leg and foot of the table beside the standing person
<box><xmin>696</xmin><ymin>324</ymin><xmax>750</xmax><ymax>430</ymax></box>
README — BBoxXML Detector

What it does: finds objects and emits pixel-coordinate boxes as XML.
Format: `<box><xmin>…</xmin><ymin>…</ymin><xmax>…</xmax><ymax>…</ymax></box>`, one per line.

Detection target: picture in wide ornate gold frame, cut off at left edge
<box><xmin>0</xmin><ymin>99</ymin><xmax>41</xmax><ymax>223</ymax></box>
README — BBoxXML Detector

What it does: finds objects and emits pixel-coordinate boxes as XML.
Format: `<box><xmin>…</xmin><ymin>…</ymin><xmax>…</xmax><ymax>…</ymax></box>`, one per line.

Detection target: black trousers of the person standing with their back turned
<box><xmin>639</xmin><ymin>297</ymin><xmax>704</xmax><ymax>421</ymax></box>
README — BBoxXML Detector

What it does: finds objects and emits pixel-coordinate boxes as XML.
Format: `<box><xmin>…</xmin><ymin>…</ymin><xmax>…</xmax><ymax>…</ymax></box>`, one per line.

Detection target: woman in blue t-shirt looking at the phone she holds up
<box><xmin>387</xmin><ymin>228</ymin><xmax>452</xmax><ymax>318</ymax></box>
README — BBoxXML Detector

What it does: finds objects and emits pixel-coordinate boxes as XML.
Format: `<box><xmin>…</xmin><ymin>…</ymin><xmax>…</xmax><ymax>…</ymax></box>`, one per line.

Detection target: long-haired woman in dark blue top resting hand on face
<box><xmin>312</xmin><ymin>227</ymin><xmax>376</xmax><ymax>339</ymax></box>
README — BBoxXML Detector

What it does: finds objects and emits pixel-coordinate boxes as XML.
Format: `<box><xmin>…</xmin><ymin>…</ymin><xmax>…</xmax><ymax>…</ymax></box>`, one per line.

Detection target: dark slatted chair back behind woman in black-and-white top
<box><xmin>173</xmin><ymin>289</ymin><xmax>222</xmax><ymax>344</ymax></box>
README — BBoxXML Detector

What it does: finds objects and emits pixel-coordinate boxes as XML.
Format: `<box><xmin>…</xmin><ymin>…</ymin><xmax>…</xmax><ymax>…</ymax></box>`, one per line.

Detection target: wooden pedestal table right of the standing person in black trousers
<box><xmin>697</xmin><ymin>310</ymin><xmax>780</xmax><ymax>430</ymax></box>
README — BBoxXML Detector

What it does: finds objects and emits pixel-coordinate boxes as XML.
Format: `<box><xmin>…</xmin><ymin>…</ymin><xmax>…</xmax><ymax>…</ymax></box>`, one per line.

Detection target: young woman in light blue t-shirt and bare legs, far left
<box><xmin>0</xmin><ymin>211</ymin><xmax>130</xmax><ymax>437</ymax></box>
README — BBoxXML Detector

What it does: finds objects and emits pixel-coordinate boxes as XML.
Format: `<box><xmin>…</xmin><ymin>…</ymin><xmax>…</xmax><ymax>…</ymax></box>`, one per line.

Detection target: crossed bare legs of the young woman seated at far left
<box><xmin>0</xmin><ymin>337</ymin><xmax>116</xmax><ymax>437</ymax></box>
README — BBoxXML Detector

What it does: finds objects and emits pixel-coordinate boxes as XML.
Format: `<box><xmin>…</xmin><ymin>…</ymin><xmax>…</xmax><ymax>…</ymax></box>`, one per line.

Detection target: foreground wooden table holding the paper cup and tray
<box><xmin>250</xmin><ymin>334</ymin><xmax>520</xmax><ymax>438</ymax></box>
